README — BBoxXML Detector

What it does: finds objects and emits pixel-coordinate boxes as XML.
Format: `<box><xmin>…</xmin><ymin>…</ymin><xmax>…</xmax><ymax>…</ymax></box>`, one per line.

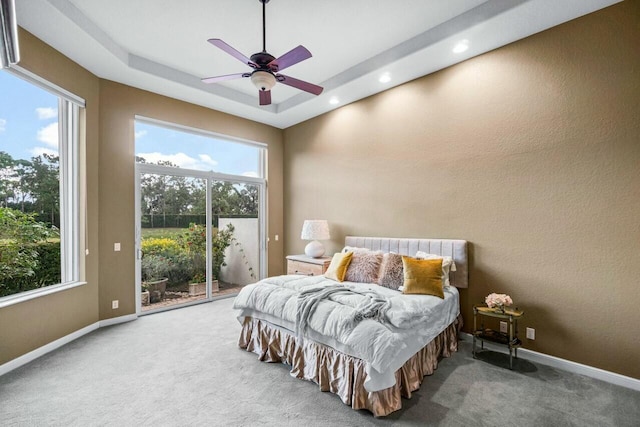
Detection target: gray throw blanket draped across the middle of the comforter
<box><xmin>296</xmin><ymin>285</ymin><xmax>390</xmax><ymax>342</ymax></box>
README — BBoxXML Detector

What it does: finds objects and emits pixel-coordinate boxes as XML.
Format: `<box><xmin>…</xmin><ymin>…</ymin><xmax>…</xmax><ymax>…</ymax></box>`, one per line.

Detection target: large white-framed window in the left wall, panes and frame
<box><xmin>0</xmin><ymin>67</ymin><xmax>84</xmax><ymax>307</ymax></box>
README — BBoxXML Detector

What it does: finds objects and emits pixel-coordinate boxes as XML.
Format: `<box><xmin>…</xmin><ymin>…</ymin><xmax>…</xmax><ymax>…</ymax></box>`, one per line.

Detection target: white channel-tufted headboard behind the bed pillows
<box><xmin>345</xmin><ymin>236</ymin><xmax>469</xmax><ymax>288</ymax></box>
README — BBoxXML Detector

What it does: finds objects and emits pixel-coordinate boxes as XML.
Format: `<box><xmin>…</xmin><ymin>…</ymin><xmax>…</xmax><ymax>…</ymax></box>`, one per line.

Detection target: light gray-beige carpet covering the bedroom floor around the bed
<box><xmin>0</xmin><ymin>299</ymin><xmax>640</xmax><ymax>427</ymax></box>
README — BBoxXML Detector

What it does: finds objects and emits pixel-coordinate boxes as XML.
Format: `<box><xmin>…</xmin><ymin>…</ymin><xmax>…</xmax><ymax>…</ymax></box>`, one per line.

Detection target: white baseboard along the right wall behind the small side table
<box><xmin>460</xmin><ymin>332</ymin><xmax>640</xmax><ymax>391</ymax></box>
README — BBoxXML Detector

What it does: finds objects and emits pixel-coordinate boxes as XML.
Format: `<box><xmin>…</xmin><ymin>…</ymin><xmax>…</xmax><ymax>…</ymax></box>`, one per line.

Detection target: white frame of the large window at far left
<box><xmin>0</xmin><ymin>65</ymin><xmax>87</xmax><ymax>308</ymax></box>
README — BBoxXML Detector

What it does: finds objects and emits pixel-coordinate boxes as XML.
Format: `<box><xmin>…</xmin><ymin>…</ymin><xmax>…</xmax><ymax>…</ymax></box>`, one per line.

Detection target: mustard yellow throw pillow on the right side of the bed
<box><xmin>402</xmin><ymin>256</ymin><xmax>444</xmax><ymax>299</ymax></box>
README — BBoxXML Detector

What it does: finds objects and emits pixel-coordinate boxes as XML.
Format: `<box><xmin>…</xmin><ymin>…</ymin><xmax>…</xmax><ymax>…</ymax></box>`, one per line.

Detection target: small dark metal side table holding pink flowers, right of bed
<box><xmin>472</xmin><ymin>305</ymin><xmax>524</xmax><ymax>369</ymax></box>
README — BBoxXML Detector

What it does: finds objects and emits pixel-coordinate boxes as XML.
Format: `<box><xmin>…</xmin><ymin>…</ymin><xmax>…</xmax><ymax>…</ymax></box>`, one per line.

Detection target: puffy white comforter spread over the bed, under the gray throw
<box><xmin>234</xmin><ymin>275</ymin><xmax>460</xmax><ymax>391</ymax></box>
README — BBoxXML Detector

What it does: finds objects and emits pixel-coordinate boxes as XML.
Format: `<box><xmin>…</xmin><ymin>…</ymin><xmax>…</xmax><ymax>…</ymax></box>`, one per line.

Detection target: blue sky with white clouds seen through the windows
<box><xmin>0</xmin><ymin>71</ymin><xmax>259</xmax><ymax>176</ymax></box>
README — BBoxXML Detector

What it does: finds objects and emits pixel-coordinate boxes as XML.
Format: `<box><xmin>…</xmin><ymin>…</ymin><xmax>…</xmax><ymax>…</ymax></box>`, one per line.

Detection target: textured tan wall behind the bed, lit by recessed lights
<box><xmin>284</xmin><ymin>2</ymin><xmax>640</xmax><ymax>378</ymax></box>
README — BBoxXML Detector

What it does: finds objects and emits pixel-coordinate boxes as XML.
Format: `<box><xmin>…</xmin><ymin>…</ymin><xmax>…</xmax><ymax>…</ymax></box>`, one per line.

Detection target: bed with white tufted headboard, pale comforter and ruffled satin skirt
<box><xmin>234</xmin><ymin>236</ymin><xmax>468</xmax><ymax>417</ymax></box>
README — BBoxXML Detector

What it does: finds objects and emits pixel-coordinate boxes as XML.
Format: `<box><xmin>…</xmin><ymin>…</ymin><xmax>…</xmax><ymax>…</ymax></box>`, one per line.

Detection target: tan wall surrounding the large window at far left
<box><xmin>0</xmin><ymin>29</ymin><xmax>99</xmax><ymax>365</ymax></box>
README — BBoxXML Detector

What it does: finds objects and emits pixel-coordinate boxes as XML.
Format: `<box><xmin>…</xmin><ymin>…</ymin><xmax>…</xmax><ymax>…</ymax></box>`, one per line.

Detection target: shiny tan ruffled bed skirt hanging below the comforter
<box><xmin>238</xmin><ymin>316</ymin><xmax>462</xmax><ymax>417</ymax></box>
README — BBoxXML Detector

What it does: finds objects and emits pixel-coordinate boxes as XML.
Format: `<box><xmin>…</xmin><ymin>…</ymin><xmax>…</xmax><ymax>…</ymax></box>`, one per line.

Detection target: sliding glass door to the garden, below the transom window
<box><xmin>136</xmin><ymin>165</ymin><xmax>265</xmax><ymax>313</ymax></box>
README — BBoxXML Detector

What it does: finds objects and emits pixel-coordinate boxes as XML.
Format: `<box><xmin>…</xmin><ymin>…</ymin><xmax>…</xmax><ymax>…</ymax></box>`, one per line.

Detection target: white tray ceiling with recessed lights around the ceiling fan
<box><xmin>16</xmin><ymin>0</ymin><xmax>620</xmax><ymax>128</ymax></box>
